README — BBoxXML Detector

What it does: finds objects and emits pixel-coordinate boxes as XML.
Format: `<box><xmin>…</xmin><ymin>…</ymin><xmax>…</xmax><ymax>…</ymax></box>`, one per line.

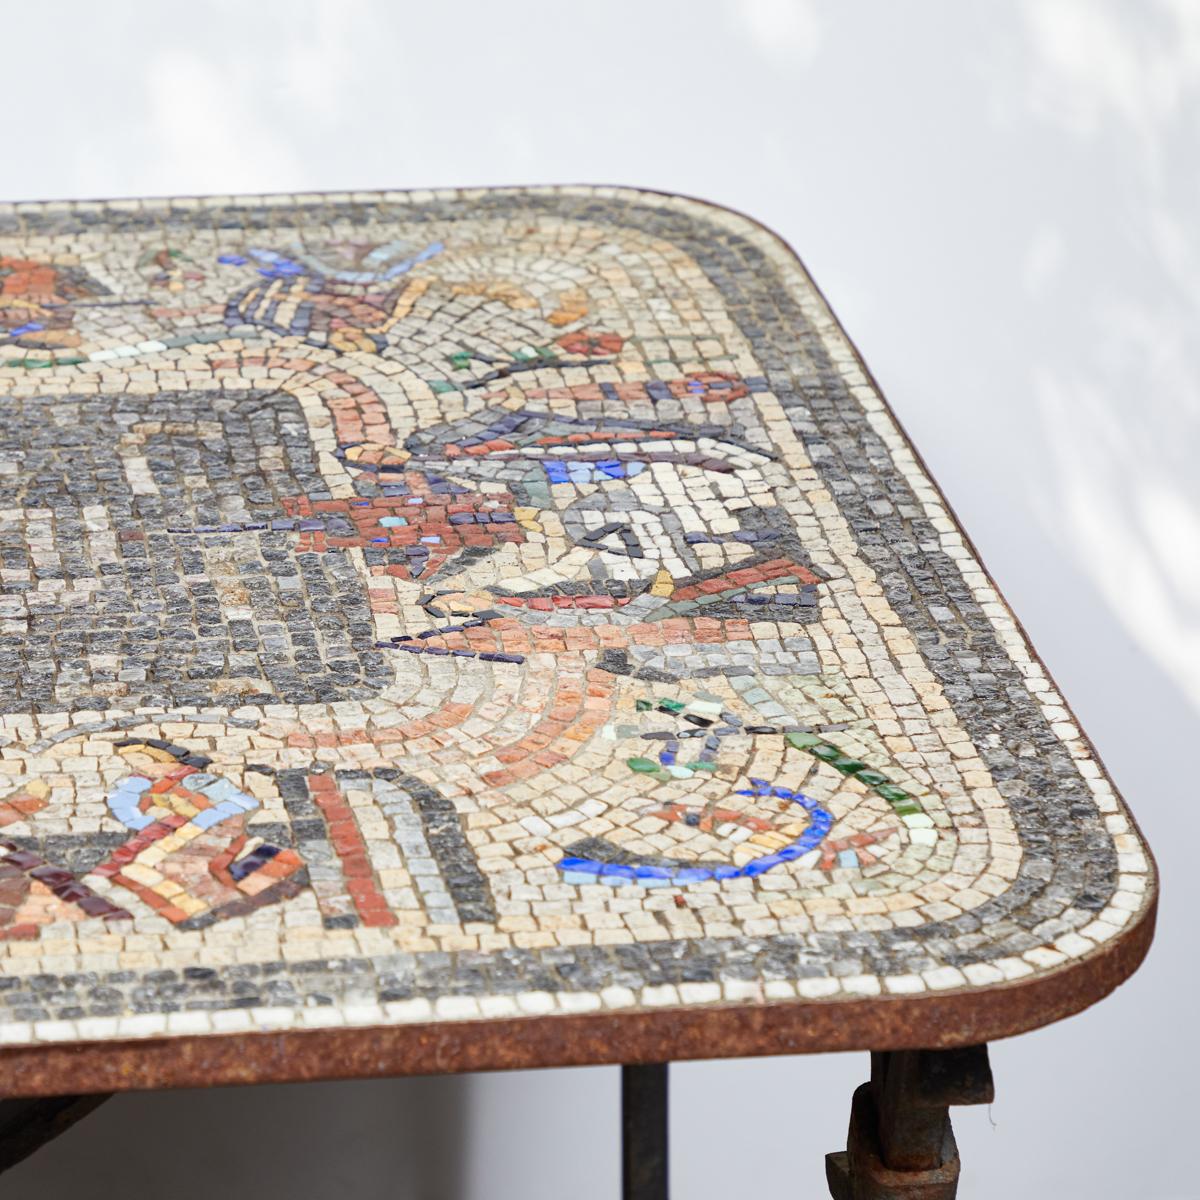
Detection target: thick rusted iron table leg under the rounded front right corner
<box><xmin>826</xmin><ymin>1046</ymin><xmax>995</xmax><ymax>1200</ymax></box>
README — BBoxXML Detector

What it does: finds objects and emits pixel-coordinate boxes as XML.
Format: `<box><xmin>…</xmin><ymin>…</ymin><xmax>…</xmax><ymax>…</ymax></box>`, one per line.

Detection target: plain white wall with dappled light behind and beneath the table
<box><xmin>0</xmin><ymin>0</ymin><xmax>1200</xmax><ymax>1200</ymax></box>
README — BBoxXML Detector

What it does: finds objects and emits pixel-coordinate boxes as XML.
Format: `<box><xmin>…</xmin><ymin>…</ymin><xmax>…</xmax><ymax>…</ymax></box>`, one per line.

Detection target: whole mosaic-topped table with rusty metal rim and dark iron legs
<box><xmin>0</xmin><ymin>187</ymin><xmax>1156</xmax><ymax>1198</ymax></box>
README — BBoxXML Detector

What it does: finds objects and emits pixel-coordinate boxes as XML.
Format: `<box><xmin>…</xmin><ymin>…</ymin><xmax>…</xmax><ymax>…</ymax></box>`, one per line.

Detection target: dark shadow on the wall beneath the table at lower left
<box><xmin>0</xmin><ymin>1075</ymin><xmax>472</xmax><ymax>1200</ymax></box>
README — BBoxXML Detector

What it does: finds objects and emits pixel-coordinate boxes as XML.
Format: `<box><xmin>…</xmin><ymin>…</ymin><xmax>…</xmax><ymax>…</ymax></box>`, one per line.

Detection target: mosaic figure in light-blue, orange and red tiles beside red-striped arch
<box><xmin>90</xmin><ymin>738</ymin><xmax>307</xmax><ymax>929</ymax></box>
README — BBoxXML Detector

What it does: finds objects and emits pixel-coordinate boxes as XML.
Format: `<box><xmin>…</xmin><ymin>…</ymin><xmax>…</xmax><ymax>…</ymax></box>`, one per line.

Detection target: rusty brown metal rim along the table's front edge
<box><xmin>0</xmin><ymin>895</ymin><xmax>1158</xmax><ymax>1097</ymax></box>
